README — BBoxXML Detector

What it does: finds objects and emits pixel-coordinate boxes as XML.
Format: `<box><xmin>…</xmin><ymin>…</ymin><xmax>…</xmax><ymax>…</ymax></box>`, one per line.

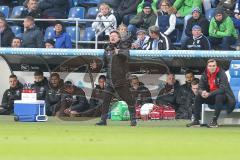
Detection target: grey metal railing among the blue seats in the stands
<box><xmin>6</xmin><ymin>18</ymin><xmax>112</xmax><ymax>49</ymax></box>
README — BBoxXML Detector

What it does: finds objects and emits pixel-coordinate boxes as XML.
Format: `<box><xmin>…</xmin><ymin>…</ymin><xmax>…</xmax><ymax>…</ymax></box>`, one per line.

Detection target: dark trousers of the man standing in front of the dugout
<box><xmin>101</xmin><ymin>84</ymin><xmax>135</xmax><ymax>120</ymax></box>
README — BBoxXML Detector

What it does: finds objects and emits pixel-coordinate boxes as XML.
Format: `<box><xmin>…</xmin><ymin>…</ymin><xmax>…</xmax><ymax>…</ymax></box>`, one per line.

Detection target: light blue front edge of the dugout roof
<box><xmin>0</xmin><ymin>48</ymin><xmax>240</xmax><ymax>58</ymax></box>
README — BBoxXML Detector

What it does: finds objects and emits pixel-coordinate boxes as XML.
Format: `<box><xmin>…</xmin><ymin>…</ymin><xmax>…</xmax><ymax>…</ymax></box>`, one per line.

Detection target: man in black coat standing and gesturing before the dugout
<box><xmin>90</xmin><ymin>30</ymin><xmax>137</xmax><ymax>126</ymax></box>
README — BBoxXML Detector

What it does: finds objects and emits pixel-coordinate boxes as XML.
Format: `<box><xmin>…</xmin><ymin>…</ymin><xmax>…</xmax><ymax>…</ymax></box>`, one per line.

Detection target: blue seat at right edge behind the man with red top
<box><xmin>229</xmin><ymin>60</ymin><xmax>240</xmax><ymax>108</ymax></box>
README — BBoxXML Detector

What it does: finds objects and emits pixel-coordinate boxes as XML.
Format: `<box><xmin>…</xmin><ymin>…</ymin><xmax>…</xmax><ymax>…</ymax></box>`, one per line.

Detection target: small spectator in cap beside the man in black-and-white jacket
<box><xmin>131</xmin><ymin>30</ymin><xmax>150</xmax><ymax>50</ymax></box>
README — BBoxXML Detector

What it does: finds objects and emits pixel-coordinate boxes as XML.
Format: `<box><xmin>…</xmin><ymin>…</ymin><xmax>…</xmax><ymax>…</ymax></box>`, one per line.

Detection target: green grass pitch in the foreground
<box><xmin>0</xmin><ymin>116</ymin><xmax>240</xmax><ymax>160</ymax></box>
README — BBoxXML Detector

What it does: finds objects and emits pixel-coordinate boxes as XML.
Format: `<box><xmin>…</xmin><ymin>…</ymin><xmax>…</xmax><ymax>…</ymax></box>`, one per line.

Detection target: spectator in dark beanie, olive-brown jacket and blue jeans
<box><xmin>128</xmin><ymin>2</ymin><xmax>157</xmax><ymax>36</ymax></box>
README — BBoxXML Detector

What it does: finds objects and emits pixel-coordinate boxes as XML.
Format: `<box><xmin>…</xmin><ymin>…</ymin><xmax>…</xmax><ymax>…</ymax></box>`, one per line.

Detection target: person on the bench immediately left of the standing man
<box><xmin>80</xmin><ymin>75</ymin><xmax>106</xmax><ymax>117</ymax></box>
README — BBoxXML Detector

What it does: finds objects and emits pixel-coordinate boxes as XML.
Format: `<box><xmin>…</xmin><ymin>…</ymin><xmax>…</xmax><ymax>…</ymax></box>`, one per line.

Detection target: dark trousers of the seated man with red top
<box><xmin>194</xmin><ymin>94</ymin><xmax>226</xmax><ymax>120</ymax></box>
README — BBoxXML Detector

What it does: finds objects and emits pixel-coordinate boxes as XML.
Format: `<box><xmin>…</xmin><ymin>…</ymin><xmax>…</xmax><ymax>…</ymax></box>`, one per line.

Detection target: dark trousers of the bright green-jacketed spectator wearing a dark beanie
<box><xmin>208</xmin><ymin>36</ymin><xmax>237</xmax><ymax>50</ymax></box>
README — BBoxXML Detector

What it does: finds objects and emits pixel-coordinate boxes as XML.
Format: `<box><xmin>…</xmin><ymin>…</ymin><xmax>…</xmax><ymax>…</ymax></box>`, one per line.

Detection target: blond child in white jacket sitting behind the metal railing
<box><xmin>92</xmin><ymin>3</ymin><xmax>117</xmax><ymax>39</ymax></box>
